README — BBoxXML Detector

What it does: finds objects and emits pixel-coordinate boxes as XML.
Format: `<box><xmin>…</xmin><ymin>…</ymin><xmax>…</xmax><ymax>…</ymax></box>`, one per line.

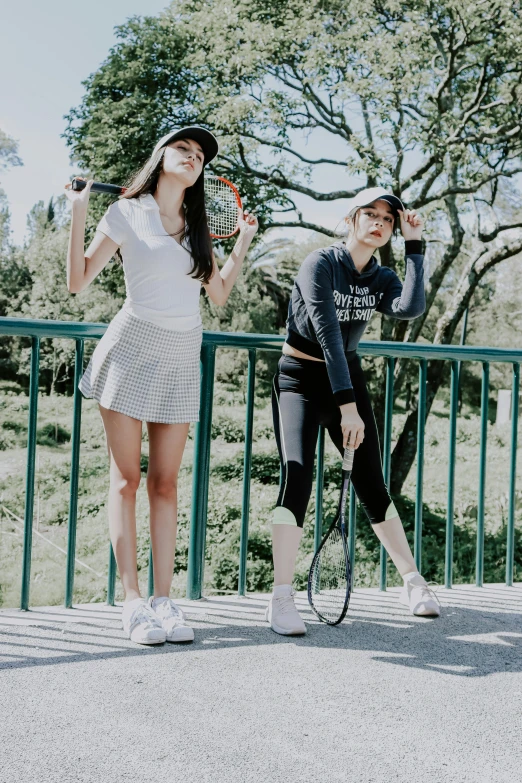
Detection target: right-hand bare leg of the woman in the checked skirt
<box><xmin>147</xmin><ymin>422</ymin><xmax>189</xmax><ymax>598</ymax></box>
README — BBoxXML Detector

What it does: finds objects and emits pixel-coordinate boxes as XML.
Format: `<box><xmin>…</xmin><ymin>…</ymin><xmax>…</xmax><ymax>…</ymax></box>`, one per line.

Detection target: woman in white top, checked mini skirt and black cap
<box><xmin>66</xmin><ymin>127</ymin><xmax>258</xmax><ymax>644</ymax></box>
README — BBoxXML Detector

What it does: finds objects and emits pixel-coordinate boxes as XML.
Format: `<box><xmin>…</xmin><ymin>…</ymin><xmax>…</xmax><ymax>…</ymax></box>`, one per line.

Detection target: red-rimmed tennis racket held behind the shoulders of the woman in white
<box><xmin>71</xmin><ymin>174</ymin><xmax>243</xmax><ymax>239</ymax></box>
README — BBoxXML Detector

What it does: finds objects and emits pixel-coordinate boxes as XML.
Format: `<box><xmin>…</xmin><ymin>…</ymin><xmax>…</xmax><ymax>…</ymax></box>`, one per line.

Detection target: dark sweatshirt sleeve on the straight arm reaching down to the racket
<box><xmin>296</xmin><ymin>252</ymin><xmax>355</xmax><ymax>405</ymax></box>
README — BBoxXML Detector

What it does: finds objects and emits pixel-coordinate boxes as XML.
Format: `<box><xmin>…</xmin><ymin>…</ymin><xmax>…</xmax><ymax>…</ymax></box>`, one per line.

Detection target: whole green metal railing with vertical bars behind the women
<box><xmin>0</xmin><ymin>318</ymin><xmax>522</xmax><ymax>610</ymax></box>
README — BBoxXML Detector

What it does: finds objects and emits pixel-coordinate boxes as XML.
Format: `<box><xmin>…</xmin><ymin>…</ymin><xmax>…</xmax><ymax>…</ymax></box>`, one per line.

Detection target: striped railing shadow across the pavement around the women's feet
<box><xmin>0</xmin><ymin>588</ymin><xmax>522</xmax><ymax>677</ymax></box>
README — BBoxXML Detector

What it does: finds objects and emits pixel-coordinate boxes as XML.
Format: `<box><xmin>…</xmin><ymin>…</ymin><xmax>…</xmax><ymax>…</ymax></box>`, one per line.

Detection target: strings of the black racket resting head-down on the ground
<box><xmin>310</xmin><ymin>527</ymin><xmax>350</xmax><ymax>623</ymax></box>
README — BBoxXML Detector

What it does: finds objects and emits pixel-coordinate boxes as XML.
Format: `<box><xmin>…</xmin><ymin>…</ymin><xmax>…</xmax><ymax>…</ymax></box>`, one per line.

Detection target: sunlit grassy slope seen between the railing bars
<box><xmin>0</xmin><ymin>378</ymin><xmax>522</xmax><ymax>606</ymax></box>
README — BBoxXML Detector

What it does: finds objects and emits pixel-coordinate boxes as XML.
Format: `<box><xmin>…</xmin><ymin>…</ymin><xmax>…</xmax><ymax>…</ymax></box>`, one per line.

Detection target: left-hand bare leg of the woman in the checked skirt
<box><xmin>100</xmin><ymin>405</ymin><xmax>141</xmax><ymax>601</ymax></box>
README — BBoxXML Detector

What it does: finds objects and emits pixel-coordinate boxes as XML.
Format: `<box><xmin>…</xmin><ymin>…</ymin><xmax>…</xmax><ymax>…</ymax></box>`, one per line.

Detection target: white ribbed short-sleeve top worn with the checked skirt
<box><xmin>97</xmin><ymin>194</ymin><xmax>201</xmax><ymax>332</ymax></box>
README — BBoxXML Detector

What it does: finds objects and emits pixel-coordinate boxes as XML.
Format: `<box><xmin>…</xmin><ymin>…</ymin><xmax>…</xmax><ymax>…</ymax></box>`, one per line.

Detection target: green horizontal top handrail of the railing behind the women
<box><xmin>0</xmin><ymin>317</ymin><xmax>522</xmax><ymax>364</ymax></box>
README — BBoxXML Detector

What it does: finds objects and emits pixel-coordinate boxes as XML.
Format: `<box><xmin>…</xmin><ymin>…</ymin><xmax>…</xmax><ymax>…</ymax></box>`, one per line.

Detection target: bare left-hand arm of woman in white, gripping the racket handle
<box><xmin>66</xmin><ymin>180</ymin><xmax>118</xmax><ymax>294</ymax></box>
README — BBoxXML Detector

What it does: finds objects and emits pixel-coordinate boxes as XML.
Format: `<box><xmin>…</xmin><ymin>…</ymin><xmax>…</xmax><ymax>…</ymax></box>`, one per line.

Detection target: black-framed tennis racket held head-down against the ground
<box><xmin>308</xmin><ymin>447</ymin><xmax>355</xmax><ymax>625</ymax></box>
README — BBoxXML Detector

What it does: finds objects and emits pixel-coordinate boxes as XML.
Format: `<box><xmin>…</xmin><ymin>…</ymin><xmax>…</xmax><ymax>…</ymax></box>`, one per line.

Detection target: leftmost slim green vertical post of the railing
<box><xmin>20</xmin><ymin>337</ymin><xmax>40</xmax><ymax>611</ymax></box>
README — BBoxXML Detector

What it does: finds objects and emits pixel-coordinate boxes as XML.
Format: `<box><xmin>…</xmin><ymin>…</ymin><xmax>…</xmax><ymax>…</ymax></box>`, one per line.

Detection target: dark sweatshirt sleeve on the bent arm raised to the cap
<box><xmin>377</xmin><ymin>239</ymin><xmax>426</xmax><ymax>321</ymax></box>
